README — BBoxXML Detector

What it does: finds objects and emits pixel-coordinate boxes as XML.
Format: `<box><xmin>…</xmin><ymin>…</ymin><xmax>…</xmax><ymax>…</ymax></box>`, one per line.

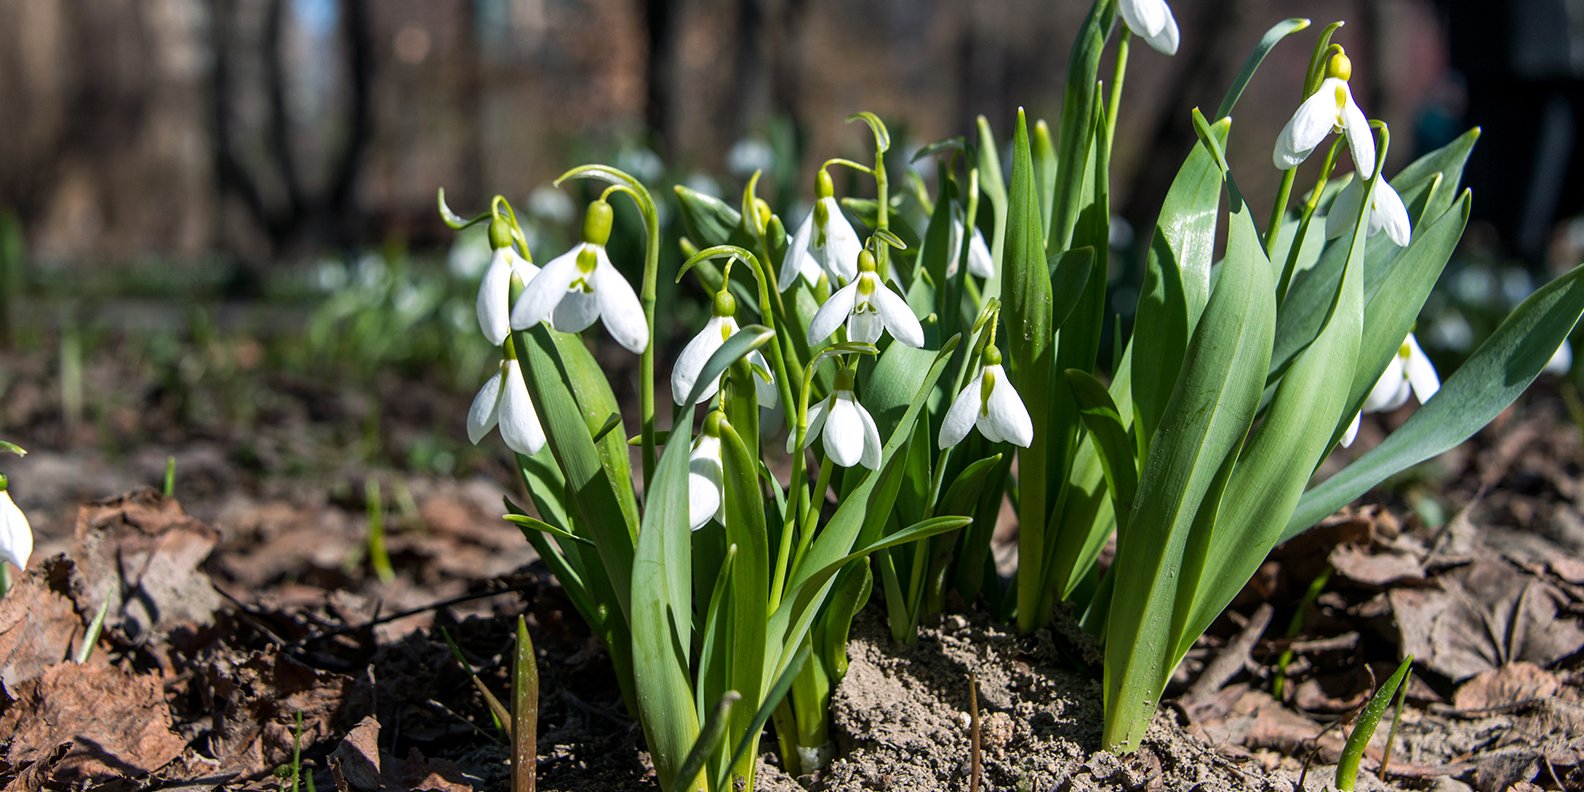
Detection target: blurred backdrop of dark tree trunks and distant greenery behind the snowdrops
<box><xmin>0</xmin><ymin>0</ymin><xmax>1584</xmax><ymax>525</ymax></box>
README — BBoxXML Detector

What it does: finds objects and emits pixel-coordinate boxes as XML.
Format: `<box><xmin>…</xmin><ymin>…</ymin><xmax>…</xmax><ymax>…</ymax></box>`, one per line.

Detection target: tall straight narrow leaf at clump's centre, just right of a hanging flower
<box><xmin>1003</xmin><ymin>109</ymin><xmax>1055</xmax><ymax>629</ymax></box>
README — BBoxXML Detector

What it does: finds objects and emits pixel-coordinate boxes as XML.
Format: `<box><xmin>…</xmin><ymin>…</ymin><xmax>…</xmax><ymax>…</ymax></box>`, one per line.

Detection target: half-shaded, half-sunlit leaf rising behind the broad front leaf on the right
<box><xmin>1133</xmin><ymin>116</ymin><xmax>1231</xmax><ymax>444</ymax></box>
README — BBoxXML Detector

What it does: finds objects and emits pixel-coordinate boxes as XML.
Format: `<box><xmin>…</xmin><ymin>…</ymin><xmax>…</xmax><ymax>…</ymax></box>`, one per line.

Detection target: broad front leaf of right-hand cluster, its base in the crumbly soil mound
<box><xmin>1102</xmin><ymin>185</ymin><xmax>1275</xmax><ymax>751</ymax></box>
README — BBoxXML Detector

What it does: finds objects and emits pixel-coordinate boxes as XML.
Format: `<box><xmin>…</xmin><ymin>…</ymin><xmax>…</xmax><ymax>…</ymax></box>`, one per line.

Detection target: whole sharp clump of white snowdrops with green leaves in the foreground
<box><xmin>440</xmin><ymin>0</ymin><xmax>1584</xmax><ymax>789</ymax></box>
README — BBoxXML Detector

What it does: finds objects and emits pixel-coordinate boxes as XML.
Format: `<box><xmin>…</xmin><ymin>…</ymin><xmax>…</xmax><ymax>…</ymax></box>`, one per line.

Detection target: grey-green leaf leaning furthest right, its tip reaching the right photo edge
<box><xmin>1281</xmin><ymin>268</ymin><xmax>1584</xmax><ymax>540</ymax></box>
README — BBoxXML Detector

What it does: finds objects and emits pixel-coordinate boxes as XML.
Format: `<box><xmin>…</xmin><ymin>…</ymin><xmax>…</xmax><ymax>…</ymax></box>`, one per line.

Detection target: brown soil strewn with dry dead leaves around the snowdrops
<box><xmin>0</xmin><ymin>342</ymin><xmax>1584</xmax><ymax>790</ymax></box>
